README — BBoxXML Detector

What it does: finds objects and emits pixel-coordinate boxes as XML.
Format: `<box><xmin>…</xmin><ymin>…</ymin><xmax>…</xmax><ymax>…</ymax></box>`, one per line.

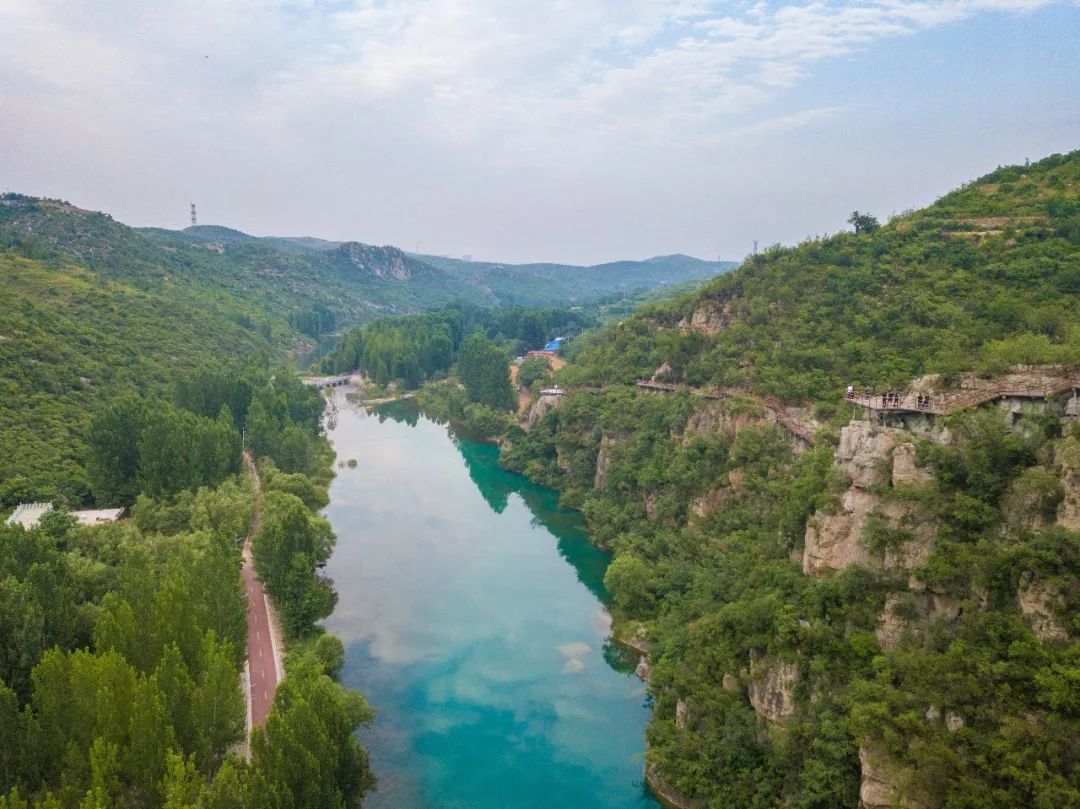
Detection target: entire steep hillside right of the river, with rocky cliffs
<box><xmin>503</xmin><ymin>152</ymin><xmax>1080</xmax><ymax>809</ymax></box>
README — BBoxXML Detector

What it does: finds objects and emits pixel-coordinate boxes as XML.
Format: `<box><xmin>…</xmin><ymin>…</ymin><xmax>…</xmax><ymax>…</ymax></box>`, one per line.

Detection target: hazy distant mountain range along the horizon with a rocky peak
<box><xmin>0</xmin><ymin>194</ymin><xmax>734</xmax><ymax>337</ymax></box>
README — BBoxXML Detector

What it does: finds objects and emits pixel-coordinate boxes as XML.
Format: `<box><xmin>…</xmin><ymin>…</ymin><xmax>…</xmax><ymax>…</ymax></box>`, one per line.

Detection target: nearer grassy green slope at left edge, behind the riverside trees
<box><xmin>0</xmin><ymin>250</ymin><xmax>271</xmax><ymax>507</ymax></box>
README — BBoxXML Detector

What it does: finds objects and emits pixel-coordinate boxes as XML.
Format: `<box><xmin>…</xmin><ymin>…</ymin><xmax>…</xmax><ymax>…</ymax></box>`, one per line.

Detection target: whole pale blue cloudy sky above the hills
<box><xmin>0</xmin><ymin>0</ymin><xmax>1080</xmax><ymax>264</ymax></box>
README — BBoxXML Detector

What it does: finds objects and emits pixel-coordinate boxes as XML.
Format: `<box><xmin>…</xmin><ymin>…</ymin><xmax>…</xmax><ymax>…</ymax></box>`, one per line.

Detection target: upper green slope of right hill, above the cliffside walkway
<box><xmin>567</xmin><ymin>152</ymin><xmax>1080</xmax><ymax>403</ymax></box>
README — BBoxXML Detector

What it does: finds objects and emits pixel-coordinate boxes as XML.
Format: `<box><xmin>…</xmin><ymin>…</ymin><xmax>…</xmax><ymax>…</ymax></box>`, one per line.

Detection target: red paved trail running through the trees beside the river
<box><xmin>243</xmin><ymin>453</ymin><xmax>278</xmax><ymax>727</ymax></box>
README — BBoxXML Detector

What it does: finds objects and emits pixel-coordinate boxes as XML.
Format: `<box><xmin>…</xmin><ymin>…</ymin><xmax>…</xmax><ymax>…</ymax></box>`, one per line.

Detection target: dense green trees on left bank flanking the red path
<box><xmin>0</xmin><ymin>356</ymin><xmax>374</xmax><ymax>809</ymax></box>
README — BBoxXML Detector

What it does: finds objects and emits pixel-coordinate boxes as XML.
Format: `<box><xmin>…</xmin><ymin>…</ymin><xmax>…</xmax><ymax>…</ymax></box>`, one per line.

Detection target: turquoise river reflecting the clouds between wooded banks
<box><xmin>325</xmin><ymin>389</ymin><xmax>658</xmax><ymax>809</ymax></box>
